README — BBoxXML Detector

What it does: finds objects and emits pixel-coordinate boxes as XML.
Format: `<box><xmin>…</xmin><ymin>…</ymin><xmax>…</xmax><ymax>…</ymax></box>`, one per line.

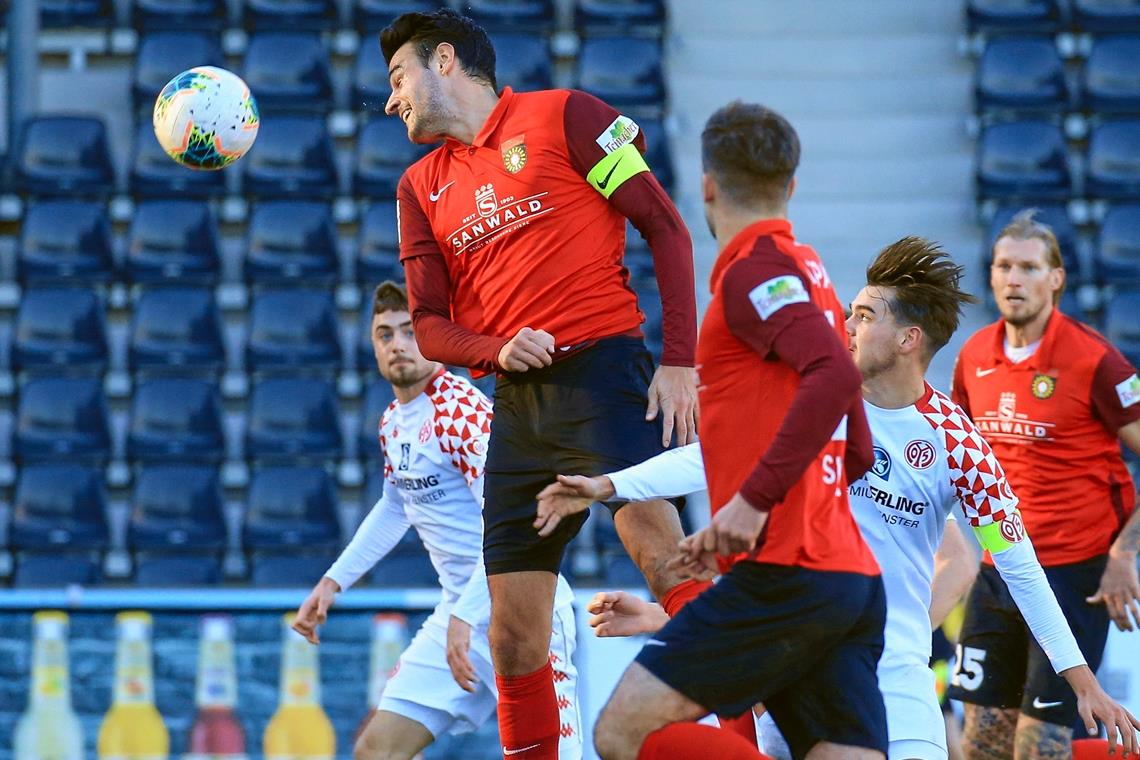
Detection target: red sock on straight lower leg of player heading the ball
<box><xmin>495</xmin><ymin>662</ymin><xmax>559</xmax><ymax>760</ymax></box>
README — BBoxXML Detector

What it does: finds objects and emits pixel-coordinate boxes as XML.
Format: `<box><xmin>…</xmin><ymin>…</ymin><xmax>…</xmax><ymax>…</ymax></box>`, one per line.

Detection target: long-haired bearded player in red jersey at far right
<box><xmin>950</xmin><ymin>212</ymin><xmax>1140</xmax><ymax>760</ymax></box>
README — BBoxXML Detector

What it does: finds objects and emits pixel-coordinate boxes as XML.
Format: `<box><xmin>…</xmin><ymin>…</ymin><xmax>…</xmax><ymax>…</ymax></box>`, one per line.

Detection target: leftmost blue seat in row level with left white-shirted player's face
<box><xmin>11</xmin><ymin>288</ymin><xmax>107</xmax><ymax>375</ymax></box>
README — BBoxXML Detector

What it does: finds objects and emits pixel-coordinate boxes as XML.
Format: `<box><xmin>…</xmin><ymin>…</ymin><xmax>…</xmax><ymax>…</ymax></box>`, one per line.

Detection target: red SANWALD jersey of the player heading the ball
<box><xmin>397</xmin><ymin>88</ymin><xmax>697</xmax><ymax>371</ymax></box>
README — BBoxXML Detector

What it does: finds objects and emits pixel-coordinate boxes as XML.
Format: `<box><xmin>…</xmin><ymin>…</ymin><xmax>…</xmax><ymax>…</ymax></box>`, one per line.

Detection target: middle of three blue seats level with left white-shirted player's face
<box><xmin>130</xmin><ymin>287</ymin><xmax>226</xmax><ymax>376</ymax></box>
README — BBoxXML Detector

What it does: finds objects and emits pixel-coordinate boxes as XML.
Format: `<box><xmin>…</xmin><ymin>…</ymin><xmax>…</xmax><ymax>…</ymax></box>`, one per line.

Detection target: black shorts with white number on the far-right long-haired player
<box><xmin>948</xmin><ymin>556</ymin><xmax>1108</xmax><ymax>733</ymax></box>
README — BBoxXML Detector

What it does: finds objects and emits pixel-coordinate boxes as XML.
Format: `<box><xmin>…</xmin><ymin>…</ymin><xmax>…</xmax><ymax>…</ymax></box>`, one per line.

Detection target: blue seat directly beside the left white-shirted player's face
<box><xmin>245</xmin><ymin>291</ymin><xmax>341</xmax><ymax>376</ymax></box>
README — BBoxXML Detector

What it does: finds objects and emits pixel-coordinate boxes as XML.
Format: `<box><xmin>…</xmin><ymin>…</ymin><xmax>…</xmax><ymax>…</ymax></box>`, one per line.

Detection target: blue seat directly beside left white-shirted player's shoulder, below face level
<box><xmin>245</xmin><ymin>378</ymin><xmax>342</xmax><ymax>461</ymax></box>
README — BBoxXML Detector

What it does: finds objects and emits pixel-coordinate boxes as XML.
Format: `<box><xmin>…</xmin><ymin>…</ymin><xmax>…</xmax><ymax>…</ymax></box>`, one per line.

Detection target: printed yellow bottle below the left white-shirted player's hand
<box><xmin>261</xmin><ymin>613</ymin><xmax>336</xmax><ymax>760</ymax></box>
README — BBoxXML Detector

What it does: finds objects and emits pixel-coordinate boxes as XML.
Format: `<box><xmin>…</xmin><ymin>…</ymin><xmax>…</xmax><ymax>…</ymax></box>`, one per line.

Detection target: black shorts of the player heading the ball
<box><xmin>483</xmin><ymin>337</ymin><xmax>662</xmax><ymax>575</ymax></box>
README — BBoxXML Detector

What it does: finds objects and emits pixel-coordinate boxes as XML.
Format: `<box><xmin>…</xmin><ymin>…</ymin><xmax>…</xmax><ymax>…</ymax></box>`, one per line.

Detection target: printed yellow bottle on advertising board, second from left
<box><xmin>98</xmin><ymin>612</ymin><xmax>170</xmax><ymax>760</ymax></box>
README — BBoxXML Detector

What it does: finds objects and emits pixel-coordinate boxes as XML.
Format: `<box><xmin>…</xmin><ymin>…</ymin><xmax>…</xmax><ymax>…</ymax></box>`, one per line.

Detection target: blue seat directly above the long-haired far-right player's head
<box><xmin>977</xmin><ymin>121</ymin><xmax>1070</xmax><ymax>201</ymax></box>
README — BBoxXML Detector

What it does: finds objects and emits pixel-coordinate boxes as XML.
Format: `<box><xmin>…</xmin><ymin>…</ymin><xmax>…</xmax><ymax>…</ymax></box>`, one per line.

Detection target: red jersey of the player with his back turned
<box><xmin>698</xmin><ymin>220</ymin><xmax>879</xmax><ymax>575</ymax></box>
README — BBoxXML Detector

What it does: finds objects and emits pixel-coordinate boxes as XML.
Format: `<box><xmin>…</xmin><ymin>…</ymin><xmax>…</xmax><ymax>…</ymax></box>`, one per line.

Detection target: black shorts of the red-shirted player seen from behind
<box><xmin>637</xmin><ymin>562</ymin><xmax>887</xmax><ymax>758</ymax></box>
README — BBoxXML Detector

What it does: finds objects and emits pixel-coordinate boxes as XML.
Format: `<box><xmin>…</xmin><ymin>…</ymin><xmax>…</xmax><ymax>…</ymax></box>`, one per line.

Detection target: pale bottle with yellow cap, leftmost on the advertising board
<box><xmin>15</xmin><ymin>612</ymin><xmax>83</xmax><ymax>760</ymax></box>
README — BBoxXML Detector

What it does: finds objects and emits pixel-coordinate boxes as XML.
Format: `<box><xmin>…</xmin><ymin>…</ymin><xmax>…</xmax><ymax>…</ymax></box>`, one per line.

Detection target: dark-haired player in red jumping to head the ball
<box><xmin>381</xmin><ymin>10</ymin><xmax>702</xmax><ymax>760</ymax></box>
